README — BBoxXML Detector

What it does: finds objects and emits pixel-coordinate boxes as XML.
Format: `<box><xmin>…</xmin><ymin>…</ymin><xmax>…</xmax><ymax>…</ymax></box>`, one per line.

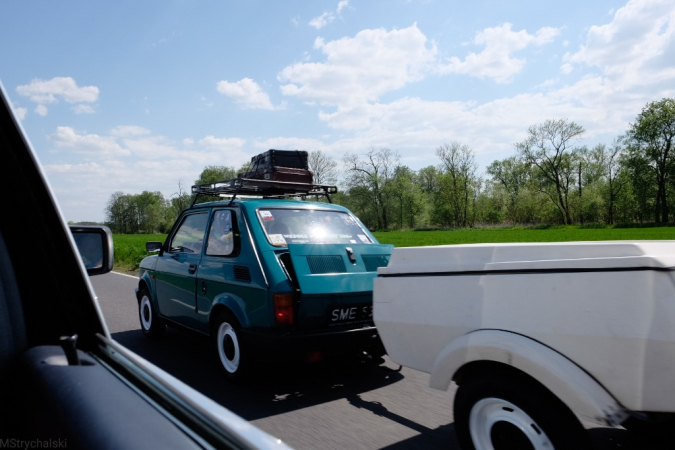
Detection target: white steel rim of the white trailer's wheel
<box><xmin>469</xmin><ymin>397</ymin><xmax>554</xmax><ymax>450</ymax></box>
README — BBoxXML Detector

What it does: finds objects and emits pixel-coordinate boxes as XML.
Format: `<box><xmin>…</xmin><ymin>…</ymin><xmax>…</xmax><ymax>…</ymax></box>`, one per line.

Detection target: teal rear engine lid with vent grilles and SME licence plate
<box><xmin>288</xmin><ymin>244</ymin><xmax>393</xmax><ymax>328</ymax></box>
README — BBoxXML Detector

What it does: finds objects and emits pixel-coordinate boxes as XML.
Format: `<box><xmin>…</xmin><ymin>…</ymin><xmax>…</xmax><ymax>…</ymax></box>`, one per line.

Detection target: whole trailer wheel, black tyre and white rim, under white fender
<box><xmin>454</xmin><ymin>373</ymin><xmax>591</xmax><ymax>450</ymax></box>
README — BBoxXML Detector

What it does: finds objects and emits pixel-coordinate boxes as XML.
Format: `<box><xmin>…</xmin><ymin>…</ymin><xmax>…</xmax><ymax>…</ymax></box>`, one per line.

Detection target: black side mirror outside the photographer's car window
<box><xmin>70</xmin><ymin>225</ymin><xmax>114</xmax><ymax>275</ymax></box>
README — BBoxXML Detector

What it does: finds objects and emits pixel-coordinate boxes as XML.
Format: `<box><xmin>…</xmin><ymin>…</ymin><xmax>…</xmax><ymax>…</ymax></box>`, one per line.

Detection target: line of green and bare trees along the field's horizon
<box><xmin>106</xmin><ymin>98</ymin><xmax>675</xmax><ymax>233</ymax></box>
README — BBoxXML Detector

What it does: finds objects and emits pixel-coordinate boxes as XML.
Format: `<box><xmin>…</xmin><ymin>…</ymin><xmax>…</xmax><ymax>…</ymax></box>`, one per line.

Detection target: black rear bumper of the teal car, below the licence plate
<box><xmin>241</xmin><ymin>326</ymin><xmax>385</xmax><ymax>361</ymax></box>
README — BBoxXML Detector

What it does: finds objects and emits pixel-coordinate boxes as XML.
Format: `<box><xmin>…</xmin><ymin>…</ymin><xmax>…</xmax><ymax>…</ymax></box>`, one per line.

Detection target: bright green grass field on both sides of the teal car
<box><xmin>113</xmin><ymin>226</ymin><xmax>675</xmax><ymax>270</ymax></box>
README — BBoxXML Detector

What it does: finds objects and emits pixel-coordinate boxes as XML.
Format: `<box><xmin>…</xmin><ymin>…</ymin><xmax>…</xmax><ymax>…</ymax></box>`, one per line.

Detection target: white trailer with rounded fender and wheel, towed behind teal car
<box><xmin>374</xmin><ymin>241</ymin><xmax>675</xmax><ymax>449</ymax></box>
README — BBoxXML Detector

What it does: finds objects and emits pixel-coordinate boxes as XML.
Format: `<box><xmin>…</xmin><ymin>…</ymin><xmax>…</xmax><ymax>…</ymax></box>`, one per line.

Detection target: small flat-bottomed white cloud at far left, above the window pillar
<box><xmin>16</xmin><ymin>77</ymin><xmax>98</xmax><ymax>104</ymax></box>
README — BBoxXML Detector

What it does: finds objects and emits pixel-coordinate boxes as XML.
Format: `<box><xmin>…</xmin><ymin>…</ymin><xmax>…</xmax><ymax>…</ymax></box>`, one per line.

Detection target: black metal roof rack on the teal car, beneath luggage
<box><xmin>190</xmin><ymin>178</ymin><xmax>337</xmax><ymax>206</ymax></box>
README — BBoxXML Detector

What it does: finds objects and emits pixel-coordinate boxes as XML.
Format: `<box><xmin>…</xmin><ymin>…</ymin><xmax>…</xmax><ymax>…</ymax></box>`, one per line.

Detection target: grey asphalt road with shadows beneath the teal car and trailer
<box><xmin>92</xmin><ymin>273</ymin><xmax>672</xmax><ymax>450</ymax></box>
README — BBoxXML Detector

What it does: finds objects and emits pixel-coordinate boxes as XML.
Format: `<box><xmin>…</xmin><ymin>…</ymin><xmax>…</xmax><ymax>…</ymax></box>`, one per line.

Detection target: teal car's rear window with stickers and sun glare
<box><xmin>258</xmin><ymin>208</ymin><xmax>373</xmax><ymax>247</ymax></box>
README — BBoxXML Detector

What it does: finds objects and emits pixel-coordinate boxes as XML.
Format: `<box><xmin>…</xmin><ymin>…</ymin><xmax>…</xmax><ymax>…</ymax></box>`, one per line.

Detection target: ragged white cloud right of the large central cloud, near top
<box><xmin>439</xmin><ymin>23</ymin><xmax>560</xmax><ymax>83</ymax></box>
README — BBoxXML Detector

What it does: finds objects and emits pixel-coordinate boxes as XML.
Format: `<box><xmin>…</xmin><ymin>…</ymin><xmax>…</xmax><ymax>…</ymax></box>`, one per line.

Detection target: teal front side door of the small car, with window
<box><xmin>155</xmin><ymin>210</ymin><xmax>209</xmax><ymax>328</ymax></box>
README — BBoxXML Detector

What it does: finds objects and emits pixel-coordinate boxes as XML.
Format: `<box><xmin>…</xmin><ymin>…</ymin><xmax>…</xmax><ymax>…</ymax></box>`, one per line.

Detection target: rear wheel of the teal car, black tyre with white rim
<box><xmin>211</xmin><ymin>312</ymin><xmax>251</xmax><ymax>381</ymax></box>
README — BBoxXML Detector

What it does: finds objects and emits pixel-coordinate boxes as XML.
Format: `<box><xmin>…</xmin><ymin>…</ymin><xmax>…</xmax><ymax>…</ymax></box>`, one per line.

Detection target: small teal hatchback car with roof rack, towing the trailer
<box><xmin>136</xmin><ymin>169</ymin><xmax>392</xmax><ymax>379</ymax></box>
